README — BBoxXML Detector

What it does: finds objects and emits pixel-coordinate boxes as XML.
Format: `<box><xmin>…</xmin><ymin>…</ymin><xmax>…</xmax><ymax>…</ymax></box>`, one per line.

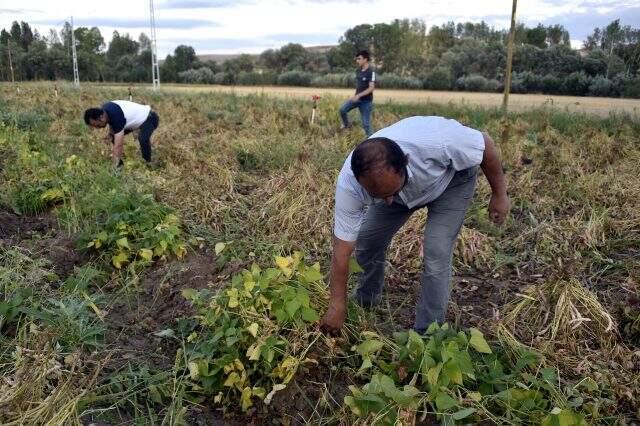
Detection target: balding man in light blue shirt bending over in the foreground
<box><xmin>321</xmin><ymin>117</ymin><xmax>509</xmax><ymax>333</ymax></box>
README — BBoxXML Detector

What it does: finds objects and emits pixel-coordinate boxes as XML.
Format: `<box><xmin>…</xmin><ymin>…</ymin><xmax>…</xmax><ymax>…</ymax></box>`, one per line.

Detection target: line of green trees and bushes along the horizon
<box><xmin>0</xmin><ymin>20</ymin><xmax>640</xmax><ymax>97</ymax></box>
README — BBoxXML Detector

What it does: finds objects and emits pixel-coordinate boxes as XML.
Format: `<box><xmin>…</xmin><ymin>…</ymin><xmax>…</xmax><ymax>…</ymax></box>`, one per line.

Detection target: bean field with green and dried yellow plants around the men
<box><xmin>0</xmin><ymin>84</ymin><xmax>640</xmax><ymax>425</ymax></box>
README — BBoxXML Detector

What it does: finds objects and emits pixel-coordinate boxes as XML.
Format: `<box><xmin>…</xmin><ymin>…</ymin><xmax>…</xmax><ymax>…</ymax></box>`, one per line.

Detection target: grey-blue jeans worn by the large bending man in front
<box><xmin>353</xmin><ymin>167</ymin><xmax>478</xmax><ymax>332</ymax></box>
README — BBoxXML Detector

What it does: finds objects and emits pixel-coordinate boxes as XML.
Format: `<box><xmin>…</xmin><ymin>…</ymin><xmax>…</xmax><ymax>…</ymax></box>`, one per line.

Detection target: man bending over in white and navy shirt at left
<box><xmin>84</xmin><ymin>101</ymin><xmax>159</xmax><ymax>167</ymax></box>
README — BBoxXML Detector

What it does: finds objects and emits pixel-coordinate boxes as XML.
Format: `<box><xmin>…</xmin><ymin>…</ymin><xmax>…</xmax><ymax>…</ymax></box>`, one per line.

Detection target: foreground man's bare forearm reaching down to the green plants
<box><xmin>320</xmin><ymin>236</ymin><xmax>355</xmax><ymax>334</ymax></box>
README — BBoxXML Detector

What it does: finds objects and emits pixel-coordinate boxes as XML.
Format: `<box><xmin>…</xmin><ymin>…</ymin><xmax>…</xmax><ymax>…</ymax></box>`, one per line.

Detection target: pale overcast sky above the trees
<box><xmin>0</xmin><ymin>0</ymin><xmax>640</xmax><ymax>58</ymax></box>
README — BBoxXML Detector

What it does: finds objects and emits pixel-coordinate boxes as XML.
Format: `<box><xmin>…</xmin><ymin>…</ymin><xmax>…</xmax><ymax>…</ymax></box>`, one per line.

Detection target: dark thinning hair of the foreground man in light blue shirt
<box><xmin>351</xmin><ymin>138</ymin><xmax>407</xmax><ymax>180</ymax></box>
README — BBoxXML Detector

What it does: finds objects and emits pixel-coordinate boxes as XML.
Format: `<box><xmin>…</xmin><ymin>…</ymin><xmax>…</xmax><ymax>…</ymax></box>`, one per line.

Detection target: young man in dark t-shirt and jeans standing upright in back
<box><xmin>340</xmin><ymin>50</ymin><xmax>376</xmax><ymax>137</ymax></box>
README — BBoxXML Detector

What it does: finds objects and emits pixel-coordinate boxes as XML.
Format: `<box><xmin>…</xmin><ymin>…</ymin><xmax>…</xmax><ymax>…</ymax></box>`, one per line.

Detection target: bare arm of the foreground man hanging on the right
<box><xmin>480</xmin><ymin>133</ymin><xmax>509</xmax><ymax>224</ymax></box>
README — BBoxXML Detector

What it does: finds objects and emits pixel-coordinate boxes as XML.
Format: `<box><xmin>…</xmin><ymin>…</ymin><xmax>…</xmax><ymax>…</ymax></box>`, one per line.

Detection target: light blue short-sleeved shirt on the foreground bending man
<box><xmin>334</xmin><ymin>116</ymin><xmax>484</xmax><ymax>241</ymax></box>
